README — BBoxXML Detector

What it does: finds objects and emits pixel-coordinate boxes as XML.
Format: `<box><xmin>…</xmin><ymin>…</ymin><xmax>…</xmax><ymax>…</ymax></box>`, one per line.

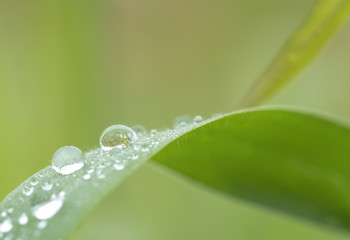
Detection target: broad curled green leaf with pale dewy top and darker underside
<box><xmin>0</xmin><ymin>109</ymin><xmax>350</xmax><ymax>240</ymax></box>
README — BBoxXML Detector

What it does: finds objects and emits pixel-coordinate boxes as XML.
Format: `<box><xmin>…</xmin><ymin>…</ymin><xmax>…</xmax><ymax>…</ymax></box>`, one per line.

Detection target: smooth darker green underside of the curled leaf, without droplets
<box><xmin>154</xmin><ymin>110</ymin><xmax>350</xmax><ymax>229</ymax></box>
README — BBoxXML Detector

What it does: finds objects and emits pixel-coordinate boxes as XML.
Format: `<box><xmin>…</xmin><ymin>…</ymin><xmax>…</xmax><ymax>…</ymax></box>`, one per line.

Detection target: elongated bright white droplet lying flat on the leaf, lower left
<box><xmin>32</xmin><ymin>192</ymin><xmax>64</xmax><ymax>220</ymax></box>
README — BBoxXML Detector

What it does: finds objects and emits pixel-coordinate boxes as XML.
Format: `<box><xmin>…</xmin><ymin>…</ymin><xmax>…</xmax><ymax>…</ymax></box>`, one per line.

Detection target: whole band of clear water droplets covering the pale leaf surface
<box><xmin>0</xmin><ymin>114</ymin><xmax>221</xmax><ymax>240</ymax></box>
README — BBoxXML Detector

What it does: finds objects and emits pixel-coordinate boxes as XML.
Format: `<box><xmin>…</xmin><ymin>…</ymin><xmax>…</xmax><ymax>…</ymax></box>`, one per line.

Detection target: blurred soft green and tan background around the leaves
<box><xmin>0</xmin><ymin>0</ymin><xmax>350</xmax><ymax>240</ymax></box>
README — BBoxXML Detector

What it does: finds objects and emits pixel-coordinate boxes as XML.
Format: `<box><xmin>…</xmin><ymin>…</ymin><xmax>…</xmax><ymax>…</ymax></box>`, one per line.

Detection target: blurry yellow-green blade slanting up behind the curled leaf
<box><xmin>242</xmin><ymin>0</ymin><xmax>350</xmax><ymax>106</ymax></box>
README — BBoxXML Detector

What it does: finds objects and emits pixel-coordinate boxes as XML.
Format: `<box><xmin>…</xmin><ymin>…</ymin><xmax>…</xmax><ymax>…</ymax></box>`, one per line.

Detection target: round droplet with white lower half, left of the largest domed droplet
<box><xmin>51</xmin><ymin>146</ymin><xmax>85</xmax><ymax>175</ymax></box>
